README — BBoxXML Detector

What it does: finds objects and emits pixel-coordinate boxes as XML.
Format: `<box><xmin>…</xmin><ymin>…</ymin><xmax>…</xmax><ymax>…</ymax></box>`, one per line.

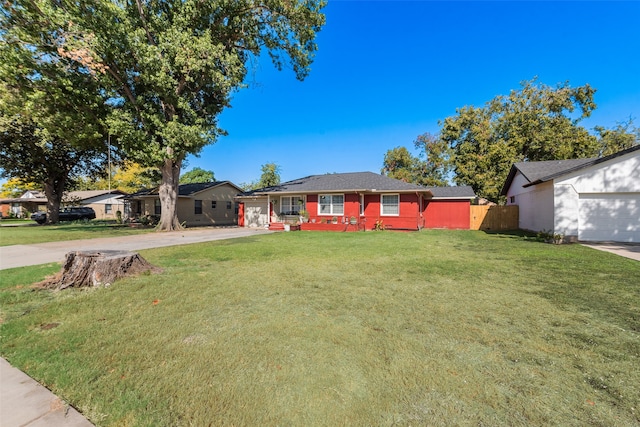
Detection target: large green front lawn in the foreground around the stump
<box><xmin>0</xmin><ymin>230</ymin><xmax>640</xmax><ymax>426</ymax></box>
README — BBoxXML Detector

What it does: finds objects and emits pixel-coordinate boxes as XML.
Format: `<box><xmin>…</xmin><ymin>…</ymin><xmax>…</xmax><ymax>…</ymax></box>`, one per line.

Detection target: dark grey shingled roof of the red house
<box><xmin>244</xmin><ymin>172</ymin><xmax>475</xmax><ymax>199</ymax></box>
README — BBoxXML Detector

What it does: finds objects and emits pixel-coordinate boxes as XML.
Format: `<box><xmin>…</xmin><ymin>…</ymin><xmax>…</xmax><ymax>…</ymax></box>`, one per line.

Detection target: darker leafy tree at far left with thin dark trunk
<box><xmin>0</xmin><ymin>1</ymin><xmax>107</xmax><ymax>223</ymax></box>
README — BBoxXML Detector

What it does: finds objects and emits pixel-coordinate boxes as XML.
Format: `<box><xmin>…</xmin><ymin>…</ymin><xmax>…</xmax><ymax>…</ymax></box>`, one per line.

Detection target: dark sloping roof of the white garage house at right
<box><xmin>500</xmin><ymin>145</ymin><xmax>640</xmax><ymax>196</ymax></box>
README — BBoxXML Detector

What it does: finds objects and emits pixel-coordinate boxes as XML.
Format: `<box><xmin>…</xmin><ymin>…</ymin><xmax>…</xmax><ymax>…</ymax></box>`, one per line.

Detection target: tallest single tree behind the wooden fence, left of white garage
<box><xmin>441</xmin><ymin>79</ymin><xmax>600</xmax><ymax>201</ymax></box>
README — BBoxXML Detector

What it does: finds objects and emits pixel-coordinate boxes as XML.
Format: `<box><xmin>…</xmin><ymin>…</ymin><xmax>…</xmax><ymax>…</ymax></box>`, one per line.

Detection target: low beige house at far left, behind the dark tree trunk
<box><xmin>0</xmin><ymin>190</ymin><xmax>126</xmax><ymax>219</ymax></box>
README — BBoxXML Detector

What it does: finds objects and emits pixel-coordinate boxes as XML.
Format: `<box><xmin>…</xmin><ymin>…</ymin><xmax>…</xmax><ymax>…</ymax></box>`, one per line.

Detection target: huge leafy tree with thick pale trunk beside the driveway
<box><xmin>4</xmin><ymin>0</ymin><xmax>325</xmax><ymax>230</ymax></box>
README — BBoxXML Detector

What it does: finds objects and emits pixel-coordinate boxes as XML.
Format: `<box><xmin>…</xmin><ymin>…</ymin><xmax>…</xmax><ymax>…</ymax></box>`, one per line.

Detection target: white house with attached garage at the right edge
<box><xmin>501</xmin><ymin>145</ymin><xmax>640</xmax><ymax>242</ymax></box>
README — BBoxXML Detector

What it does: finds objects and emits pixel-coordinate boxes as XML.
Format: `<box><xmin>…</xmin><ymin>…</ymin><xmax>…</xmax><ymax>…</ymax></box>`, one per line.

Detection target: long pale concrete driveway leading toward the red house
<box><xmin>0</xmin><ymin>227</ymin><xmax>272</xmax><ymax>270</ymax></box>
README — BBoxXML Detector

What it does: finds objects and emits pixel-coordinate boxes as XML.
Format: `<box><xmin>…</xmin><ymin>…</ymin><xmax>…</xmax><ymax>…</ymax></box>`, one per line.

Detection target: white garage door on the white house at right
<box><xmin>578</xmin><ymin>193</ymin><xmax>640</xmax><ymax>242</ymax></box>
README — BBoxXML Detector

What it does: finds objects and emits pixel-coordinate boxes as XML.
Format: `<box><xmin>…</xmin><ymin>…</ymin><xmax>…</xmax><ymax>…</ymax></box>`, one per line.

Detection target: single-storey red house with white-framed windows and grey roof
<box><xmin>237</xmin><ymin>172</ymin><xmax>475</xmax><ymax>230</ymax></box>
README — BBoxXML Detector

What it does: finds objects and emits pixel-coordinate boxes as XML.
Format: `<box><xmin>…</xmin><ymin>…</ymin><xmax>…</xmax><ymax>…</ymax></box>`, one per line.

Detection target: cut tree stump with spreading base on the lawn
<box><xmin>34</xmin><ymin>250</ymin><xmax>161</xmax><ymax>290</ymax></box>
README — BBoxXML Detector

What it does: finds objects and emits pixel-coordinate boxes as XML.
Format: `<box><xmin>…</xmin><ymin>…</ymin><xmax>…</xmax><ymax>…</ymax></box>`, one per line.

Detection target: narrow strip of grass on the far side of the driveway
<box><xmin>0</xmin><ymin>220</ymin><xmax>153</xmax><ymax>246</ymax></box>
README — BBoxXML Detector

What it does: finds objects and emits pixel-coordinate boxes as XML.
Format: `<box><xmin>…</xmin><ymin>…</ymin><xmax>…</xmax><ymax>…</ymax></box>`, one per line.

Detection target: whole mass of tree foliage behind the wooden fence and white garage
<box><xmin>390</xmin><ymin>79</ymin><xmax>640</xmax><ymax>202</ymax></box>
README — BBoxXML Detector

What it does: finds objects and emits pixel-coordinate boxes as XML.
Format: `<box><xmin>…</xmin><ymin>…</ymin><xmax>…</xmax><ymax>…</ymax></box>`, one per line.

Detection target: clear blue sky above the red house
<box><xmin>189</xmin><ymin>0</ymin><xmax>640</xmax><ymax>184</ymax></box>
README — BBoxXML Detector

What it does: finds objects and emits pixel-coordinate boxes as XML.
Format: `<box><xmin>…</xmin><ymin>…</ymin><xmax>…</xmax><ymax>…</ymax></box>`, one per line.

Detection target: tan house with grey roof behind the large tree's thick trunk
<box><xmin>127</xmin><ymin>181</ymin><xmax>242</xmax><ymax>227</ymax></box>
